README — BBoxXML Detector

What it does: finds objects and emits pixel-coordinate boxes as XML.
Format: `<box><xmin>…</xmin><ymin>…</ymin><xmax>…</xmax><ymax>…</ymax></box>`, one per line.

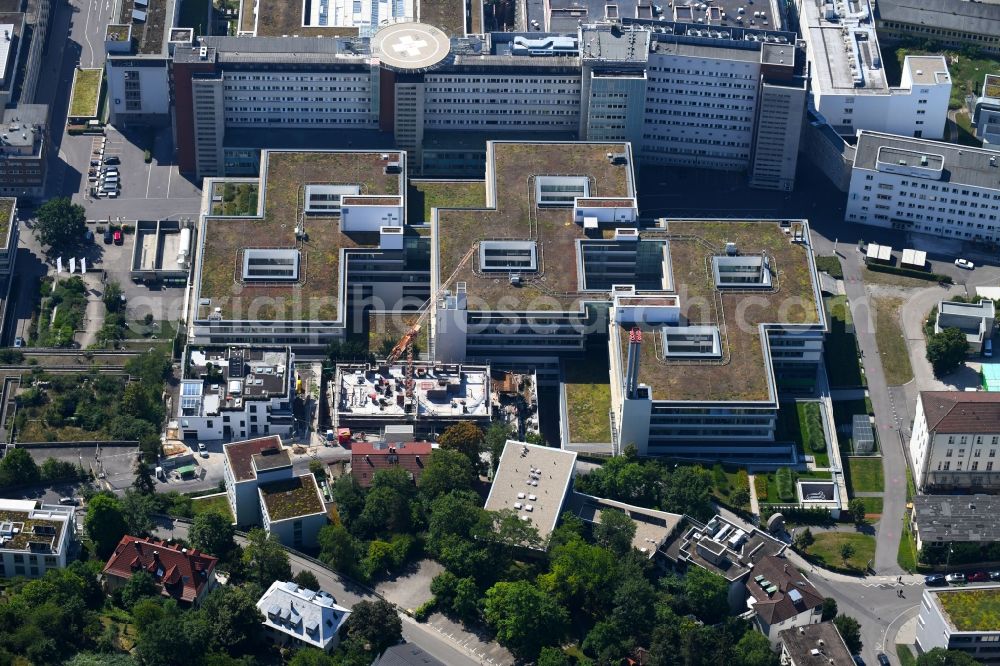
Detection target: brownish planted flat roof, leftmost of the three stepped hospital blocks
<box><xmin>198</xmin><ymin>151</ymin><xmax>405</xmax><ymax>321</ymax></box>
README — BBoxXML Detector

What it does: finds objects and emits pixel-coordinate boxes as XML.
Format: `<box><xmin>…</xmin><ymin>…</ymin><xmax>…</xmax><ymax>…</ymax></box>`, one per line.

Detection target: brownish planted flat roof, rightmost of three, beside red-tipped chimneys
<box><xmin>618</xmin><ymin>220</ymin><xmax>820</xmax><ymax>401</ymax></box>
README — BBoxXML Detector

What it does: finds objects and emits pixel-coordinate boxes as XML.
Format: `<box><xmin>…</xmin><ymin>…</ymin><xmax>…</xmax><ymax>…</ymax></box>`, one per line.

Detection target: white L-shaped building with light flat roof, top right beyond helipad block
<box><xmin>796</xmin><ymin>0</ymin><xmax>951</xmax><ymax>139</ymax></box>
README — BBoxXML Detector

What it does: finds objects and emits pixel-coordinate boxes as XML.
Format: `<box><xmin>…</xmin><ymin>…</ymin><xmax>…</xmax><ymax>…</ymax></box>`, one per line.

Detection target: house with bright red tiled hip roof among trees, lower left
<box><xmin>102</xmin><ymin>534</ymin><xmax>219</xmax><ymax>606</ymax></box>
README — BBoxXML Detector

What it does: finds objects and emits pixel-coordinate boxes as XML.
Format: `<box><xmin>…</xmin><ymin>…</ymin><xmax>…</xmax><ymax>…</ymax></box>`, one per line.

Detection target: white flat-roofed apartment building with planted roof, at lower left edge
<box><xmin>0</xmin><ymin>499</ymin><xmax>76</xmax><ymax>578</ymax></box>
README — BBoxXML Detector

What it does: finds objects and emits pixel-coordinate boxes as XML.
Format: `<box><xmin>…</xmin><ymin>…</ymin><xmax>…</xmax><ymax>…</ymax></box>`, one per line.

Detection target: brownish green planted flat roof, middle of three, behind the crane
<box><xmin>432</xmin><ymin>141</ymin><xmax>634</xmax><ymax>311</ymax></box>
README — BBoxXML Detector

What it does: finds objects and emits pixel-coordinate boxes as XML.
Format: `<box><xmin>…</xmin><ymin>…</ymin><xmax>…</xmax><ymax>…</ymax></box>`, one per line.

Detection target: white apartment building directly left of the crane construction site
<box><xmin>176</xmin><ymin>345</ymin><xmax>295</xmax><ymax>440</ymax></box>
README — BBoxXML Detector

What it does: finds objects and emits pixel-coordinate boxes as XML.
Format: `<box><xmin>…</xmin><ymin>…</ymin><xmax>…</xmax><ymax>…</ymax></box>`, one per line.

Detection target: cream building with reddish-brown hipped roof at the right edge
<box><xmin>909</xmin><ymin>391</ymin><xmax>1000</xmax><ymax>492</ymax></box>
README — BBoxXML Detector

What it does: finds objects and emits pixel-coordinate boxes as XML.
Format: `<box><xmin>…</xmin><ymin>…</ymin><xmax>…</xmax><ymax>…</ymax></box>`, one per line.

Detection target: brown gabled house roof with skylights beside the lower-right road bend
<box><xmin>747</xmin><ymin>556</ymin><xmax>823</xmax><ymax>625</ymax></box>
